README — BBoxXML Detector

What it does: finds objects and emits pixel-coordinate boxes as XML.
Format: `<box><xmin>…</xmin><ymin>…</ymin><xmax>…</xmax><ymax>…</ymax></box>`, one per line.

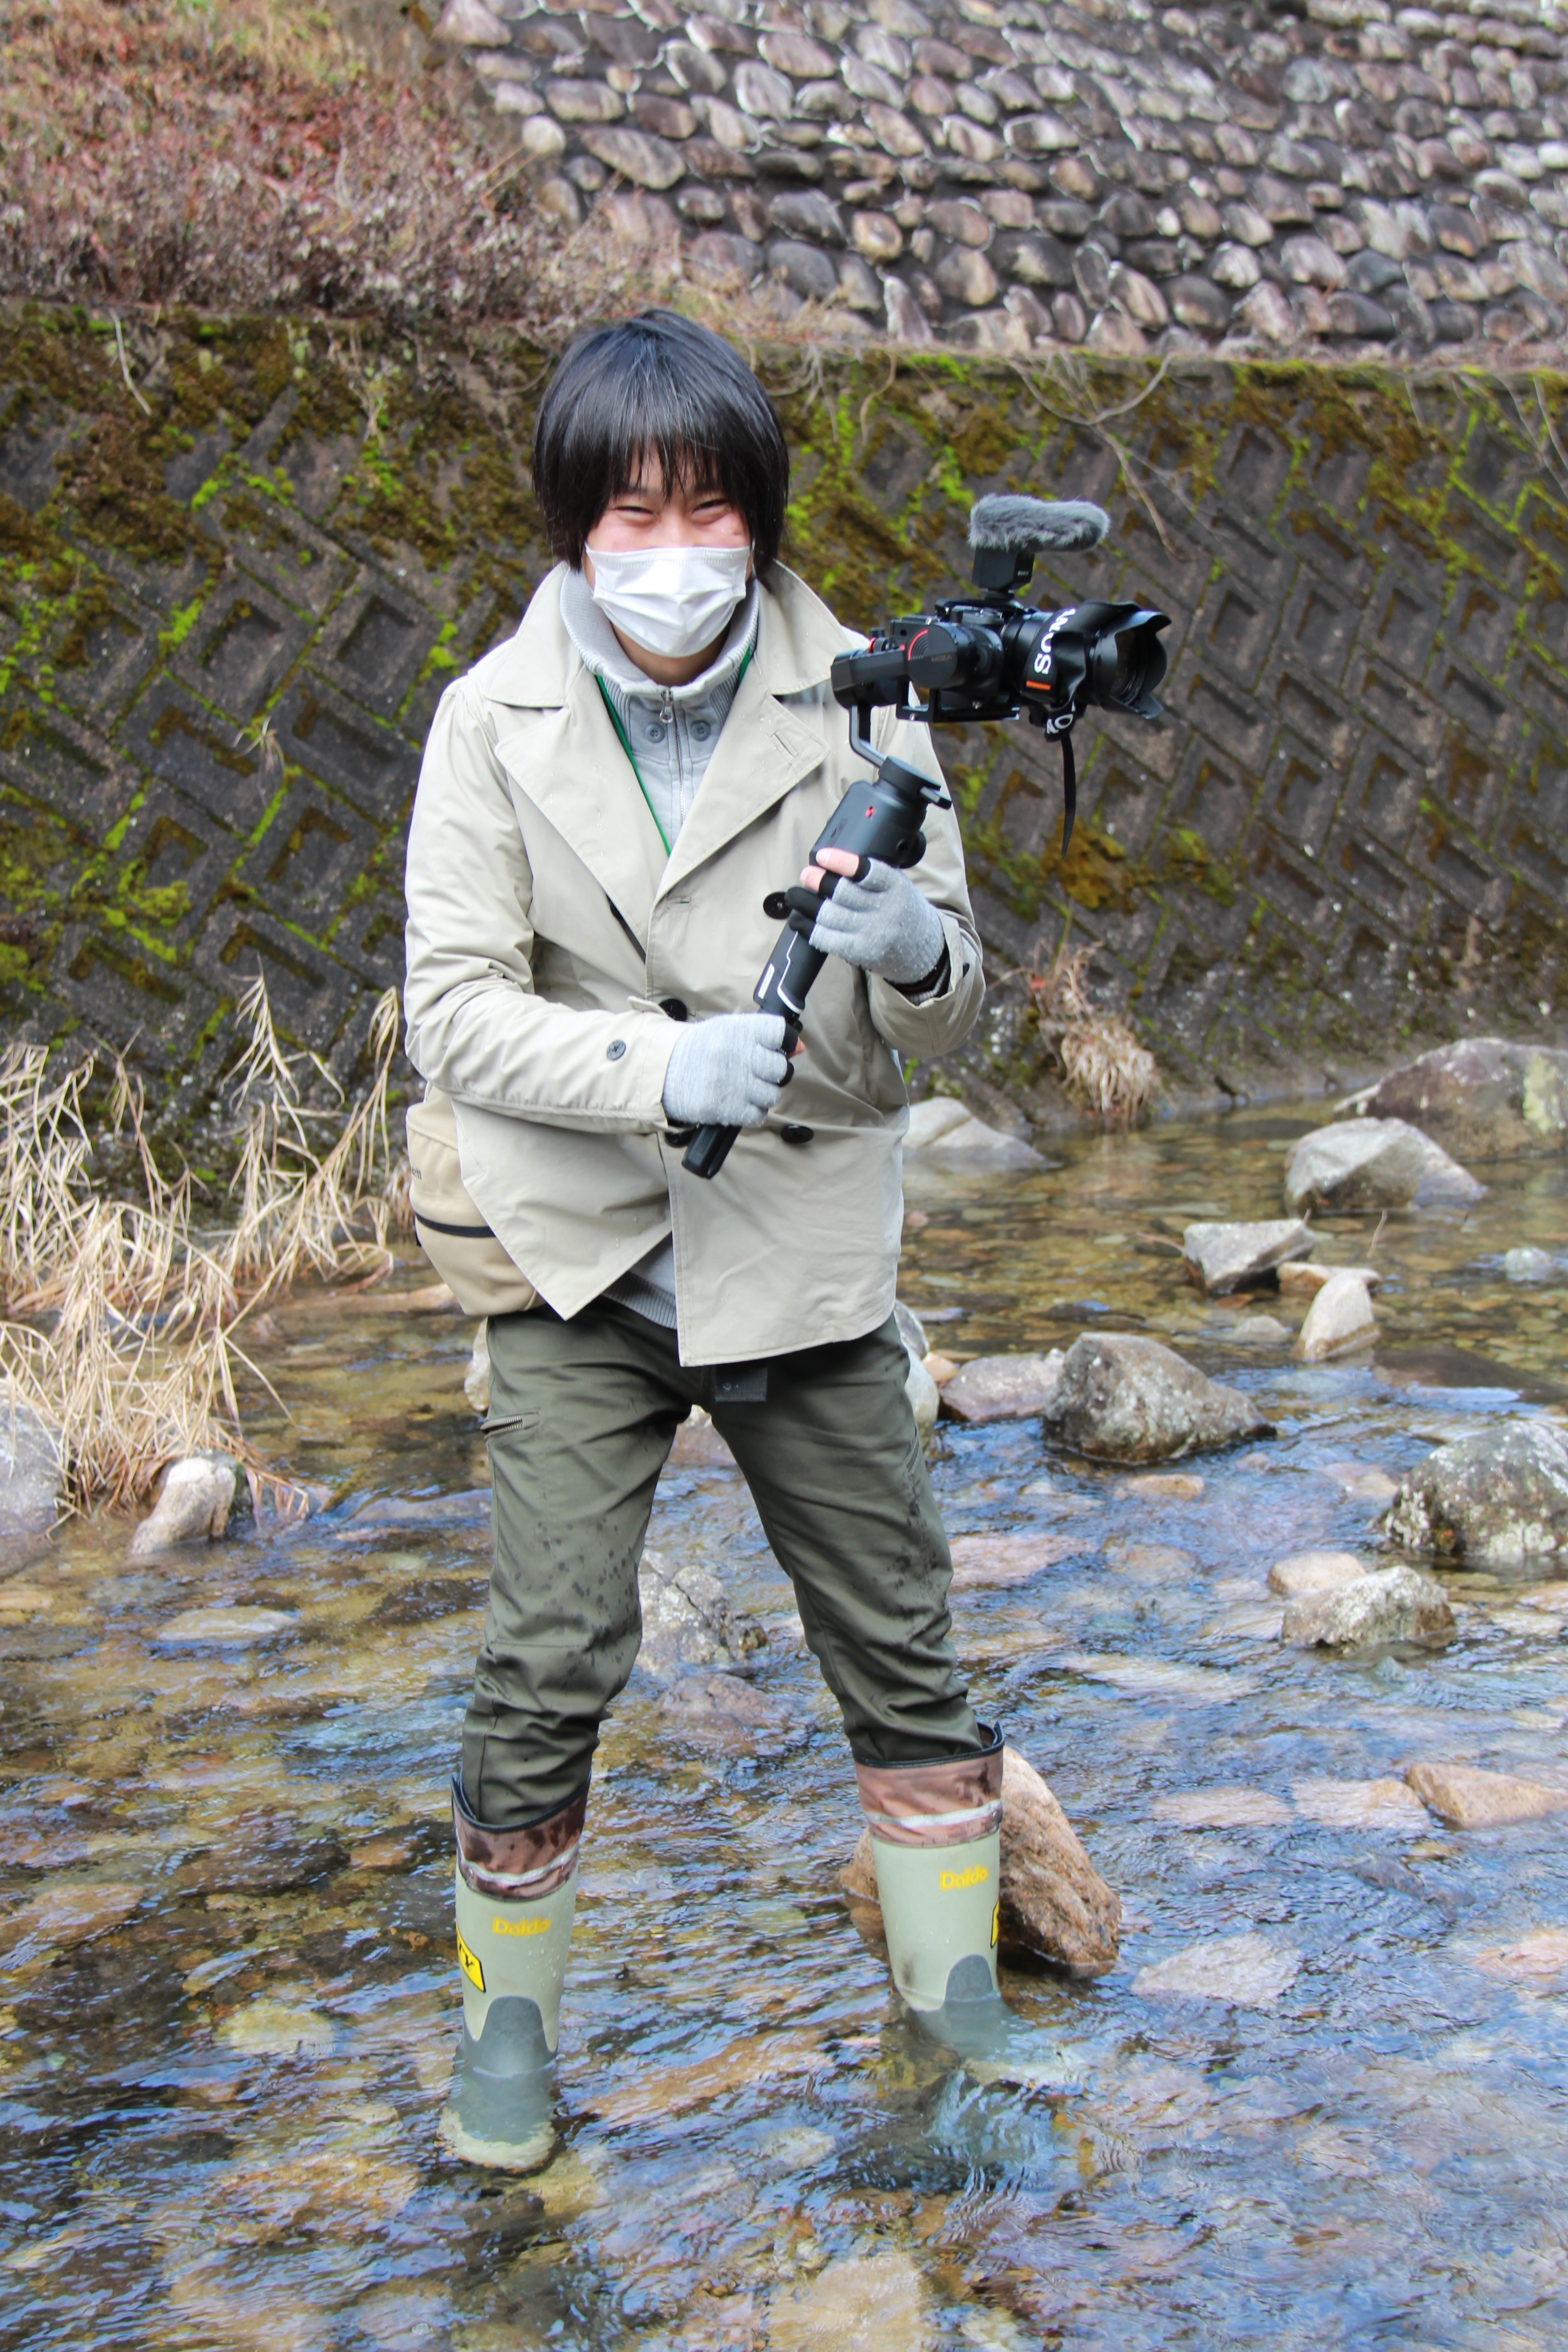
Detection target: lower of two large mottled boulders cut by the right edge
<box><xmin>1385</xmin><ymin>1421</ymin><xmax>1568</xmax><ymax>1567</ymax></box>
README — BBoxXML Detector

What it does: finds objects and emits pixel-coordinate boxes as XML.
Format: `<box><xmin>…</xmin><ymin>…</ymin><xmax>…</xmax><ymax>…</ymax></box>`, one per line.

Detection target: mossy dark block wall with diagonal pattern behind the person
<box><xmin>0</xmin><ymin>310</ymin><xmax>1568</xmax><ymax>1127</ymax></box>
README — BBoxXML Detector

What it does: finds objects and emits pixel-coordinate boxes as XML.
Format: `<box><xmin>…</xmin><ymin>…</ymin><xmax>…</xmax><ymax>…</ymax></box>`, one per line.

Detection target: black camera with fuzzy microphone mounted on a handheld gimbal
<box><xmin>682</xmin><ymin>496</ymin><xmax>1171</xmax><ymax>1176</ymax></box>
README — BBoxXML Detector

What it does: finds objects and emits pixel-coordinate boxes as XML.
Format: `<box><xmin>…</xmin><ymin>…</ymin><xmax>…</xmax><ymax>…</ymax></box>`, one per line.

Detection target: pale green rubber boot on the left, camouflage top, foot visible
<box><xmin>440</xmin><ymin>1778</ymin><xmax>588</xmax><ymax>2173</ymax></box>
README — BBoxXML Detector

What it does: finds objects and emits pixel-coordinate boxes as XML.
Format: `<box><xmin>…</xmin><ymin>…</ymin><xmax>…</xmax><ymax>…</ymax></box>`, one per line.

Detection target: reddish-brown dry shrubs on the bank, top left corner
<box><xmin>0</xmin><ymin>0</ymin><xmax>573</xmax><ymax>327</ymax></box>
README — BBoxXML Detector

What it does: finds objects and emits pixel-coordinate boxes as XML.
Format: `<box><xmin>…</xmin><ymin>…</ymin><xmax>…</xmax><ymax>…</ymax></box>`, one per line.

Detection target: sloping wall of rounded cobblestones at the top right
<box><xmin>435</xmin><ymin>0</ymin><xmax>1568</xmax><ymax>362</ymax></box>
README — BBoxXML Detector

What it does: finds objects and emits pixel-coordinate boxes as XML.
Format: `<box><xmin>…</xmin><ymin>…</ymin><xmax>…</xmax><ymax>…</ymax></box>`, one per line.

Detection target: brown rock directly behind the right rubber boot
<box><xmin>844</xmin><ymin>1748</ymin><xmax>1122</xmax><ymax>1976</ymax></box>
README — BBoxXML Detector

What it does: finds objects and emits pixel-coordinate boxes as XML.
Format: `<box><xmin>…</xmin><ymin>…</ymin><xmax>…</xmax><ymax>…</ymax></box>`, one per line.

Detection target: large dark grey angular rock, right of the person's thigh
<box><xmin>1044</xmin><ymin>1331</ymin><xmax>1274</xmax><ymax>1463</ymax></box>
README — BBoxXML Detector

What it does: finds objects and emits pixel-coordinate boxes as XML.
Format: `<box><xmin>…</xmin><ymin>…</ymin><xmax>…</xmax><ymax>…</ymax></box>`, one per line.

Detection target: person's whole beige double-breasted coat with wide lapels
<box><xmin>407</xmin><ymin>567</ymin><xmax>985</xmax><ymax>1364</ymax></box>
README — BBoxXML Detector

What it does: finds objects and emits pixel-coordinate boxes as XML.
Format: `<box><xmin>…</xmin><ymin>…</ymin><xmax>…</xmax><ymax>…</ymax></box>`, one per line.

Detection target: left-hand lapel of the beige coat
<box><xmin>496</xmin><ymin>663</ymin><xmax>663</xmax><ymax>941</ymax></box>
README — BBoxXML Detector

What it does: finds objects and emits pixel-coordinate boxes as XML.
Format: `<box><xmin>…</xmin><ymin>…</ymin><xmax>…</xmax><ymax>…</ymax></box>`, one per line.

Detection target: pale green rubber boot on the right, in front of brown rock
<box><xmin>856</xmin><ymin>1724</ymin><xmax>1011</xmax><ymax>2056</ymax></box>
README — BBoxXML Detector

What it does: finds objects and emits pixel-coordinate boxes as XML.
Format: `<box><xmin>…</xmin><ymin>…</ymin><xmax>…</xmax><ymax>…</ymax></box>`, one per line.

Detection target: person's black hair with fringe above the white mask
<box><xmin>534</xmin><ymin>310</ymin><xmax>790</xmax><ymax>578</ymax></box>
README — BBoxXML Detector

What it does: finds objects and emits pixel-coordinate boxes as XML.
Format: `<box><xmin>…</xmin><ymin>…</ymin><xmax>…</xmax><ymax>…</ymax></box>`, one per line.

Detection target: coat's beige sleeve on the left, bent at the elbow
<box><xmin>404</xmin><ymin>680</ymin><xmax>679</xmax><ymax>1132</ymax></box>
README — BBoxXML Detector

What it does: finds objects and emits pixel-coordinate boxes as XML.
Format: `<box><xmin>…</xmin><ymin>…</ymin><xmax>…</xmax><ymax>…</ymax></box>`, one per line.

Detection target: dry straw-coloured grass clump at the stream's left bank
<box><xmin>0</xmin><ymin>981</ymin><xmax>407</xmax><ymax>1510</ymax></box>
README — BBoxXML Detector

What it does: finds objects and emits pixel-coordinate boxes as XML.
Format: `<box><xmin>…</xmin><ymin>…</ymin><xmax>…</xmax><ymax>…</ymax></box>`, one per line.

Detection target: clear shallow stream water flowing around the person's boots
<box><xmin>0</xmin><ymin>1105</ymin><xmax>1568</xmax><ymax>2352</ymax></box>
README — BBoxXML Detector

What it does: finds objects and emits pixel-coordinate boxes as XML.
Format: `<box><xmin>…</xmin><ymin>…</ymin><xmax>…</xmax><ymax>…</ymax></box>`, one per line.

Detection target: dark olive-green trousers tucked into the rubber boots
<box><xmin>463</xmin><ymin>1298</ymin><xmax>983</xmax><ymax>1828</ymax></box>
